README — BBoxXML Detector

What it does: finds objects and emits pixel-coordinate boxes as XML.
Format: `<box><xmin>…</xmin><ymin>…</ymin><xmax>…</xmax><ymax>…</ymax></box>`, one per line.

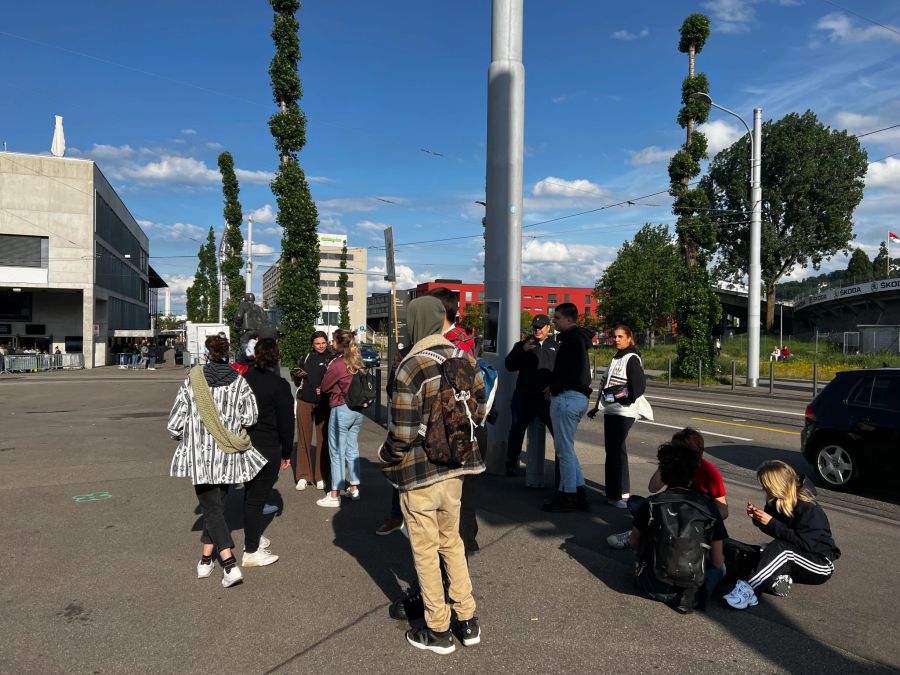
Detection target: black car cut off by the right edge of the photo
<box><xmin>800</xmin><ymin>368</ymin><xmax>900</xmax><ymax>490</ymax></box>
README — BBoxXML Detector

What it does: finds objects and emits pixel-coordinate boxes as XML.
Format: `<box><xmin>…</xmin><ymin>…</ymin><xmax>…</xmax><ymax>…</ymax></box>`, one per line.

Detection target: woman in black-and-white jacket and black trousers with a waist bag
<box><xmin>588</xmin><ymin>325</ymin><xmax>653</xmax><ymax>509</ymax></box>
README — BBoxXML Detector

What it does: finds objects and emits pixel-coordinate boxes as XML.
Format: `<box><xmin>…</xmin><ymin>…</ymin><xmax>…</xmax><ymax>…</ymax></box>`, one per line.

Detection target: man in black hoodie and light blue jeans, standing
<box><xmin>541</xmin><ymin>302</ymin><xmax>593</xmax><ymax>513</ymax></box>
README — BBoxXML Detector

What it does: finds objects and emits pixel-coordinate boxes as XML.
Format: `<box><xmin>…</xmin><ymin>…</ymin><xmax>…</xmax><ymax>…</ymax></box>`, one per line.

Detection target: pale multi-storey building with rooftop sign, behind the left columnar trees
<box><xmin>262</xmin><ymin>234</ymin><xmax>368</xmax><ymax>334</ymax></box>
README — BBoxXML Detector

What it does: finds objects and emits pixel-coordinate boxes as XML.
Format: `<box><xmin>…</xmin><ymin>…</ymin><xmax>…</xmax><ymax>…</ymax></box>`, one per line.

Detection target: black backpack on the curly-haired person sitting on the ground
<box><xmin>648</xmin><ymin>488</ymin><xmax>716</xmax><ymax>589</ymax></box>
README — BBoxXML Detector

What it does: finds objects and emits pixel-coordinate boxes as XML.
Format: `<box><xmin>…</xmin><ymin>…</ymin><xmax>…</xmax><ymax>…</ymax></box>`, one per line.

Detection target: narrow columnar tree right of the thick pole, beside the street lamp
<box><xmin>669</xmin><ymin>14</ymin><xmax>721</xmax><ymax>377</ymax></box>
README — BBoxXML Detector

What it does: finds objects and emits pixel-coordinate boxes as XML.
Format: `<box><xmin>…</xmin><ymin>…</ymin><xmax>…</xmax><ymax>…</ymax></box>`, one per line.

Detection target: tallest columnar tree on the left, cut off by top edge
<box><xmin>269</xmin><ymin>0</ymin><xmax>322</xmax><ymax>366</ymax></box>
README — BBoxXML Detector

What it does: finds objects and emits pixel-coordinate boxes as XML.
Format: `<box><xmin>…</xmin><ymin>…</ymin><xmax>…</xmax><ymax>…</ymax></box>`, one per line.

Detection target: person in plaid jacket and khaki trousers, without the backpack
<box><xmin>379</xmin><ymin>296</ymin><xmax>485</xmax><ymax>654</ymax></box>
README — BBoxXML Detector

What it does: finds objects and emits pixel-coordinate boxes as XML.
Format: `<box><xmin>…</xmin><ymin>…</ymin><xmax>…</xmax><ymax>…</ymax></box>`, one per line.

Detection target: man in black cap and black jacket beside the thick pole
<box><xmin>506</xmin><ymin>314</ymin><xmax>558</xmax><ymax>487</ymax></box>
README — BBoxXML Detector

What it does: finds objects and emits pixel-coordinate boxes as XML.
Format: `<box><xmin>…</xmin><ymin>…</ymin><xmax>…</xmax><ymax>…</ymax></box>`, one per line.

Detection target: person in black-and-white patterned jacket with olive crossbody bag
<box><xmin>167</xmin><ymin>336</ymin><xmax>266</xmax><ymax>588</ymax></box>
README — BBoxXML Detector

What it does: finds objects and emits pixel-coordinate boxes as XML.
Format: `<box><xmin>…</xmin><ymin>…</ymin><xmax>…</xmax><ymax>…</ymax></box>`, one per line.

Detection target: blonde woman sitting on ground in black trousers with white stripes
<box><xmin>724</xmin><ymin>459</ymin><xmax>841</xmax><ymax>609</ymax></box>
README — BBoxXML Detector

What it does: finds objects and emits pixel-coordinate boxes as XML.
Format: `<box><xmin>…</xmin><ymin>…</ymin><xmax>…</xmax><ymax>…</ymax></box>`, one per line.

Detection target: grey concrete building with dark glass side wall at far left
<box><xmin>0</xmin><ymin>152</ymin><xmax>165</xmax><ymax>368</ymax></box>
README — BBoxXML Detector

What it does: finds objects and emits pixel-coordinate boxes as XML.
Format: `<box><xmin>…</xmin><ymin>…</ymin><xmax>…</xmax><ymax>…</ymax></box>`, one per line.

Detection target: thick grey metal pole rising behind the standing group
<box><xmin>484</xmin><ymin>0</ymin><xmax>525</xmax><ymax>473</ymax></box>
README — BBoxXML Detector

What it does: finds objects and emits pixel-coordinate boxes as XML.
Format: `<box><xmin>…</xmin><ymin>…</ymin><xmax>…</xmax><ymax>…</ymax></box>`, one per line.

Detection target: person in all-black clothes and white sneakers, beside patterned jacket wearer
<box><xmin>241</xmin><ymin>338</ymin><xmax>294</xmax><ymax>567</ymax></box>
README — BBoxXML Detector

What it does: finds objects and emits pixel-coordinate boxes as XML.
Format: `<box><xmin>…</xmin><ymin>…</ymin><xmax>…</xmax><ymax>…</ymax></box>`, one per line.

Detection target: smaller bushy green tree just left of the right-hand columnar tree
<box><xmin>594</xmin><ymin>224</ymin><xmax>684</xmax><ymax>346</ymax></box>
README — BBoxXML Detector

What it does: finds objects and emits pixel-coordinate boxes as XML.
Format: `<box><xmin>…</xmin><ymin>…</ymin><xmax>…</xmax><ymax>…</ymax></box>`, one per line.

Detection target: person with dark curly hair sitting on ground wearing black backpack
<box><xmin>628</xmin><ymin>440</ymin><xmax>727</xmax><ymax>613</ymax></box>
